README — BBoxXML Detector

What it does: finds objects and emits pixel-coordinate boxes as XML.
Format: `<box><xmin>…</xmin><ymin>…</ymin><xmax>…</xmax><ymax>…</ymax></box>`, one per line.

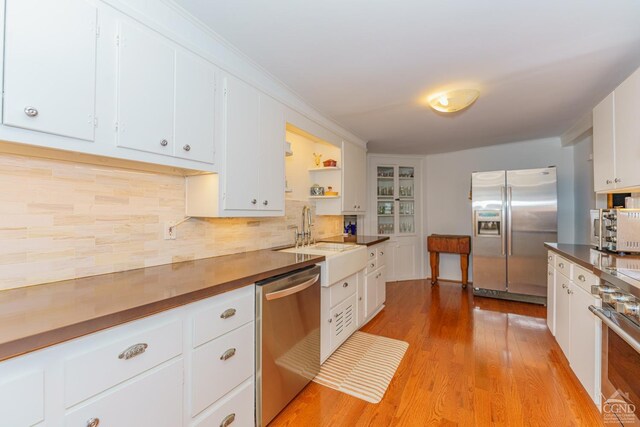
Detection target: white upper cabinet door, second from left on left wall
<box><xmin>118</xmin><ymin>22</ymin><xmax>175</xmax><ymax>155</ymax></box>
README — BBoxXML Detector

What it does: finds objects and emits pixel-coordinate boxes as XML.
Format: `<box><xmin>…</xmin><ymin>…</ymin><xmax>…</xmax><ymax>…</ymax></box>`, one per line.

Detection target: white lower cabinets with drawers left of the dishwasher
<box><xmin>0</xmin><ymin>285</ymin><xmax>255</xmax><ymax>427</ymax></box>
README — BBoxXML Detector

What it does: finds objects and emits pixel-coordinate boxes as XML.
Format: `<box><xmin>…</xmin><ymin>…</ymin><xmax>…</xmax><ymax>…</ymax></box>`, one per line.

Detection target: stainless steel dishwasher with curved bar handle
<box><xmin>256</xmin><ymin>266</ymin><xmax>320</xmax><ymax>426</ymax></box>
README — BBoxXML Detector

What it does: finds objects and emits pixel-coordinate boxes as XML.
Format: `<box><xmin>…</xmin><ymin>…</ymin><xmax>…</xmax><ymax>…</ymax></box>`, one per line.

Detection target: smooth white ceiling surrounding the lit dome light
<box><xmin>175</xmin><ymin>0</ymin><xmax>640</xmax><ymax>154</ymax></box>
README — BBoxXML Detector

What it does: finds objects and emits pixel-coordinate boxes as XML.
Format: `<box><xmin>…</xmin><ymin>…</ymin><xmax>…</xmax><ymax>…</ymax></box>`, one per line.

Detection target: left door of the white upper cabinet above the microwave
<box><xmin>593</xmin><ymin>92</ymin><xmax>616</xmax><ymax>191</ymax></box>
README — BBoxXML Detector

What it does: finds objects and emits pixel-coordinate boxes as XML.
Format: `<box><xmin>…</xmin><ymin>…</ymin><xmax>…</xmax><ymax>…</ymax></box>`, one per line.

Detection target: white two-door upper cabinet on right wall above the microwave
<box><xmin>593</xmin><ymin>65</ymin><xmax>640</xmax><ymax>192</ymax></box>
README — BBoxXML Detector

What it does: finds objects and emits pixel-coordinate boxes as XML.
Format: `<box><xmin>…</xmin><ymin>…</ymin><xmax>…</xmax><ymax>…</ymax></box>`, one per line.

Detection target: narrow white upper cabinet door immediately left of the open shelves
<box><xmin>254</xmin><ymin>94</ymin><xmax>285</xmax><ymax>211</ymax></box>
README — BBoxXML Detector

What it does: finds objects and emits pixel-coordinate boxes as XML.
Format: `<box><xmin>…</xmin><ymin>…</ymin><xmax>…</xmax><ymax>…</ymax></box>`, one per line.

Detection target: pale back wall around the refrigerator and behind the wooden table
<box><xmin>423</xmin><ymin>138</ymin><xmax>576</xmax><ymax>280</ymax></box>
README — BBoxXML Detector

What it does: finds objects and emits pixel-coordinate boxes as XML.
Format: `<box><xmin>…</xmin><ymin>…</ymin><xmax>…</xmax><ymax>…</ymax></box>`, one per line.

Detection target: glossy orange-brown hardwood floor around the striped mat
<box><xmin>270</xmin><ymin>280</ymin><xmax>603</xmax><ymax>427</ymax></box>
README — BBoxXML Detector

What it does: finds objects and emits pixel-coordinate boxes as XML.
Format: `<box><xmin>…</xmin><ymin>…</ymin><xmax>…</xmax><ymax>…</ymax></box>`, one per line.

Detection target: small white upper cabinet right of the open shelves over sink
<box><xmin>342</xmin><ymin>141</ymin><xmax>367</xmax><ymax>213</ymax></box>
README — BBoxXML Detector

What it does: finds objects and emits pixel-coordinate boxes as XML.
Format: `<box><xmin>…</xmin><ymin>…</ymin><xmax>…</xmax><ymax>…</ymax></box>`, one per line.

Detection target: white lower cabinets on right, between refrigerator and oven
<box><xmin>547</xmin><ymin>254</ymin><xmax>602</xmax><ymax>406</ymax></box>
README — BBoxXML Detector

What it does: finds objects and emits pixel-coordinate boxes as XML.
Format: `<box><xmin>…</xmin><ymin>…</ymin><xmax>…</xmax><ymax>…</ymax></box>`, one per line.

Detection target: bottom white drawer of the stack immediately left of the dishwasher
<box><xmin>194</xmin><ymin>378</ymin><xmax>255</xmax><ymax>427</ymax></box>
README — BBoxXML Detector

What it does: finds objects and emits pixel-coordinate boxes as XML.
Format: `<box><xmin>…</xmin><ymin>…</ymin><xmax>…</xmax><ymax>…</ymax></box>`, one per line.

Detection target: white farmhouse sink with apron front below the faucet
<box><xmin>278</xmin><ymin>243</ymin><xmax>367</xmax><ymax>287</ymax></box>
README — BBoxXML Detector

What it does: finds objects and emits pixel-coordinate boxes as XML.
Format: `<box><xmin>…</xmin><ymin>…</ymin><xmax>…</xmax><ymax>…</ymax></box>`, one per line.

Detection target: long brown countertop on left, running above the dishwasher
<box><xmin>0</xmin><ymin>250</ymin><xmax>325</xmax><ymax>361</ymax></box>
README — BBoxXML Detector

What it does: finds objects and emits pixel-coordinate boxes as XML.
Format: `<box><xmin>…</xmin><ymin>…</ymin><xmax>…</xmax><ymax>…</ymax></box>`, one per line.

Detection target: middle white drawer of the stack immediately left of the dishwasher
<box><xmin>191</xmin><ymin>322</ymin><xmax>255</xmax><ymax>416</ymax></box>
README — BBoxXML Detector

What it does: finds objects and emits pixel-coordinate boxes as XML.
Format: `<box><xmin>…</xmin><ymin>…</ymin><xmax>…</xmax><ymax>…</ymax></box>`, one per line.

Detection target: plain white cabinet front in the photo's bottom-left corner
<box><xmin>0</xmin><ymin>371</ymin><xmax>44</xmax><ymax>426</ymax></box>
